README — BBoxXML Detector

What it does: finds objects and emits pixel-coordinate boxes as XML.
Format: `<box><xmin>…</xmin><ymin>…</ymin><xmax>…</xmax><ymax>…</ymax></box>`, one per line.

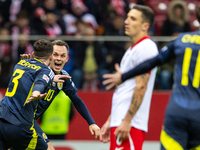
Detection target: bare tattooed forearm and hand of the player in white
<box><xmin>114</xmin><ymin>73</ymin><xmax>149</xmax><ymax>141</ymax></box>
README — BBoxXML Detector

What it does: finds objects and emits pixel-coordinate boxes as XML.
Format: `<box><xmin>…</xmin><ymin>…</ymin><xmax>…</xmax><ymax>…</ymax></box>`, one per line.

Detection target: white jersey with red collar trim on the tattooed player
<box><xmin>110</xmin><ymin>36</ymin><xmax>158</xmax><ymax>132</ymax></box>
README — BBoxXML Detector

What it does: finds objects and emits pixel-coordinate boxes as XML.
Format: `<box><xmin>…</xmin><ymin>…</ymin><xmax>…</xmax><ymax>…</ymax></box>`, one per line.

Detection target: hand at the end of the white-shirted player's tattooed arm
<box><xmin>114</xmin><ymin>120</ymin><xmax>131</xmax><ymax>142</ymax></box>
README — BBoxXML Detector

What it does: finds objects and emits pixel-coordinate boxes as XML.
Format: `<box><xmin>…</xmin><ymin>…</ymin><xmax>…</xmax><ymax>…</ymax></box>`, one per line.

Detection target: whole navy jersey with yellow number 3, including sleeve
<box><xmin>0</xmin><ymin>58</ymin><xmax>54</xmax><ymax>125</ymax></box>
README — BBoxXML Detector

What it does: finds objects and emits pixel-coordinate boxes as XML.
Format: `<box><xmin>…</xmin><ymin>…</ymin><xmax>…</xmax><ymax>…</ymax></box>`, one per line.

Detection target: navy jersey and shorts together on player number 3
<box><xmin>0</xmin><ymin>58</ymin><xmax>54</xmax><ymax>150</ymax></box>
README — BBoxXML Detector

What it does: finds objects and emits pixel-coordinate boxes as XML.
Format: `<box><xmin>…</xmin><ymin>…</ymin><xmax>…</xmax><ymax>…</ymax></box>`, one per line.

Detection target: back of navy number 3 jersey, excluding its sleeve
<box><xmin>1</xmin><ymin>59</ymin><xmax>49</xmax><ymax>124</ymax></box>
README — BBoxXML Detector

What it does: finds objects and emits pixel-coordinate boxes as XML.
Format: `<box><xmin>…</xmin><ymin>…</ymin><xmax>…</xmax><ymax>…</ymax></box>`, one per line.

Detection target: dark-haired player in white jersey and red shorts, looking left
<box><xmin>100</xmin><ymin>5</ymin><xmax>158</xmax><ymax>150</ymax></box>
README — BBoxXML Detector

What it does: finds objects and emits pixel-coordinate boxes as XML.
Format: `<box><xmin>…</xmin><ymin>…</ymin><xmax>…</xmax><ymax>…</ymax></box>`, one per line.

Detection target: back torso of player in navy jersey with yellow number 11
<box><xmin>172</xmin><ymin>31</ymin><xmax>200</xmax><ymax>109</ymax></box>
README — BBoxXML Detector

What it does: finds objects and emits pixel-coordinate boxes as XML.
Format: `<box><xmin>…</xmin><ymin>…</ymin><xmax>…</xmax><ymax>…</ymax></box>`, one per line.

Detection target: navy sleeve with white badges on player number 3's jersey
<box><xmin>32</xmin><ymin>68</ymin><xmax>54</xmax><ymax>93</ymax></box>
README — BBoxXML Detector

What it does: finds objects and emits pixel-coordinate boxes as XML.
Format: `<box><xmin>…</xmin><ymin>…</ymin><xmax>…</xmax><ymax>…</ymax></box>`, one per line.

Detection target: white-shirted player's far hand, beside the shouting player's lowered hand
<box><xmin>100</xmin><ymin>121</ymin><xmax>110</xmax><ymax>143</ymax></box>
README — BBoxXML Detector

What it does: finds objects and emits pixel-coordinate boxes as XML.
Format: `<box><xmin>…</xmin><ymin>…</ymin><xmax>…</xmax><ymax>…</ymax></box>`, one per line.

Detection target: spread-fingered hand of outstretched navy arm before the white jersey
<box><xmin>102</xmin><ymin>64</ymin><xmax>122</xmax><ymax>90</ymax></box>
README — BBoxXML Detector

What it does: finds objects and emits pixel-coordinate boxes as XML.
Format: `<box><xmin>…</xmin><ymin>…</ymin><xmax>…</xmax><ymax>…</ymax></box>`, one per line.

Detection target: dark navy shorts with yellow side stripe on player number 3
<box><xmin>0</xmin><ymin>119</ymin><xmax>48</xmax><ymax>150</ymax></box>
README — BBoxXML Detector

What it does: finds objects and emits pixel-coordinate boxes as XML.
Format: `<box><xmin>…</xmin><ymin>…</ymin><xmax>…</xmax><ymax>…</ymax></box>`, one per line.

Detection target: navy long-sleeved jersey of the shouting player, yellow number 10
<box><xmin>35</xmin><ymin>70</ymin><xmax>95</xmax><ymax>125</ymax></box>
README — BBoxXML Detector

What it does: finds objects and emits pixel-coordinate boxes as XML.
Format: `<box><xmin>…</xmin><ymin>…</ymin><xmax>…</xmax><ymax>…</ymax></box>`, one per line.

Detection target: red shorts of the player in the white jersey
<box><xmin>110</xmin><ymin>127</ymin><xmax>145</xmax><ymax>150</ymax></box>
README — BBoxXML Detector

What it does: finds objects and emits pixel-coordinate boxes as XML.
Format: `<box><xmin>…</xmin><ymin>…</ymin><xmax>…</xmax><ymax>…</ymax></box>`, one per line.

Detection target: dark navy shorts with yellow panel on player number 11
<box><xmin>160</xmin><ymin>108</ymin><xmax>200</xmax><ymax>150</ymax></box>
